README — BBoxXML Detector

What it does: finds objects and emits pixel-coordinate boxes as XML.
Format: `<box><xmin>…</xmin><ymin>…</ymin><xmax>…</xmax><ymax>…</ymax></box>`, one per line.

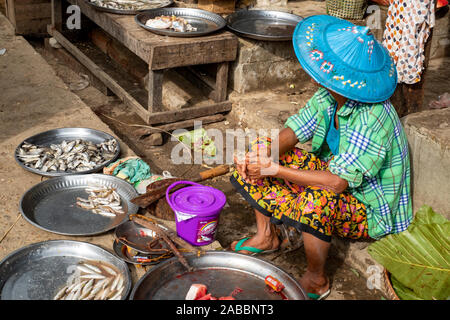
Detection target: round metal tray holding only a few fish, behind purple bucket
<box><xmin>19</xmin><ymin>174</ymin><xmax>139</xmax><ymax>236</ymax></box>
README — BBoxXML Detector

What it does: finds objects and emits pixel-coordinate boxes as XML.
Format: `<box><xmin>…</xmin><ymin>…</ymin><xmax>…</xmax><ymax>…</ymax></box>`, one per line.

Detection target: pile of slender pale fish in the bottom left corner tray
<box><xmin>53</xmin><ymin>262</ymin><xmax>125</xmax><ymax>300</ymax></box>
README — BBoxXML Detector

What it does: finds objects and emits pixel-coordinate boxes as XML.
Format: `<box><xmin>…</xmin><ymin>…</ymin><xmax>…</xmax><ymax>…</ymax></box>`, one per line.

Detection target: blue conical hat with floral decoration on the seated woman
<box><xmin>292</xmin><ymin>15</ymin><xmax>397</xmax><ymax>103</ymax></box>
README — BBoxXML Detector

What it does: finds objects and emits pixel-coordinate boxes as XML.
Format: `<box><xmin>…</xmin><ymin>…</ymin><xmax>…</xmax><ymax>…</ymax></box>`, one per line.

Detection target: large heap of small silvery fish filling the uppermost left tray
<box><xmin>17</xmin><ymin>139</ymin><xmax>118</xmax><ymax>172</ymax></box>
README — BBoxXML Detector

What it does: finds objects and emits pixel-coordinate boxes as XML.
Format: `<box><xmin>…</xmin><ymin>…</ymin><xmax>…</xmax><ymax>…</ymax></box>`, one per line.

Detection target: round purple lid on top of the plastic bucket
<box><xmin>170</xmin><ymin>186</ymin><xmax>227</xmax><ymax>215</ymax></box>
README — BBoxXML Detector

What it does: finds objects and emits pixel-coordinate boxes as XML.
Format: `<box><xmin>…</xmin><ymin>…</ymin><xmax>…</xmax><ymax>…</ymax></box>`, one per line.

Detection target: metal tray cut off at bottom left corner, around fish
<box><xmin>0</xmin><ymin>240</ymin><xmax>131</xmax><ymax>300</ymax></box>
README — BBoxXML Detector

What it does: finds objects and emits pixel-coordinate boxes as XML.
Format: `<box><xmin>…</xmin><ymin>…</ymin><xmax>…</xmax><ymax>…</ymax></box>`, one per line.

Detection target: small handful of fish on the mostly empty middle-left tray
<box><xmin>76</xmin><ymin>186</ymin><xmax>125</xmax><ymax>217</ymax></box>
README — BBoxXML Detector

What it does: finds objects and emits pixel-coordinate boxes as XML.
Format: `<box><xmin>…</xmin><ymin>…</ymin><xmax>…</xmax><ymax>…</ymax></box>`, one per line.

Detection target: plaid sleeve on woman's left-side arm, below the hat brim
<box><xmin>284</xmin><ymin>91</ymin><xmax>322</xmax><ymax>143</ymax></box>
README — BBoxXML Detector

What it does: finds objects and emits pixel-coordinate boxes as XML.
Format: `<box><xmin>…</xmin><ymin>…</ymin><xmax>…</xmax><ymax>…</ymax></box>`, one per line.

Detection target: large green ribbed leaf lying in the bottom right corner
<box><xmin>368</xmin><ymin>206</ymin><xmax>450</xmax><ymax>300</ymax></box>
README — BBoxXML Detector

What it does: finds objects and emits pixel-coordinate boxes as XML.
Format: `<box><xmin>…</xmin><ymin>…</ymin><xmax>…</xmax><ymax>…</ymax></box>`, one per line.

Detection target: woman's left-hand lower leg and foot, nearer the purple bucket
<box><xmin>231</xmin><ymin>209</ymin><xmax>280</xmax><ymax>254</ymax></box>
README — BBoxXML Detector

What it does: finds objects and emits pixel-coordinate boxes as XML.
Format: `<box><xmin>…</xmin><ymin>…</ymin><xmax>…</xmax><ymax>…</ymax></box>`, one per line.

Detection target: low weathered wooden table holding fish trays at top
<box><xmin>48</xmin><ymin>0</ymin><xmax>238</xmax><ymax>124</ymax></box>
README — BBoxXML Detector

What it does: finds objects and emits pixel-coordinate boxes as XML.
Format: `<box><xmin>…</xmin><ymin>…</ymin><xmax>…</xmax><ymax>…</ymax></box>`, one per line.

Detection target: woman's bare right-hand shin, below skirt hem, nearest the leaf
<box><xmin>300</xmin><ymin>232</ymin><xmax>331</xmax><ymax>295</ymax></box>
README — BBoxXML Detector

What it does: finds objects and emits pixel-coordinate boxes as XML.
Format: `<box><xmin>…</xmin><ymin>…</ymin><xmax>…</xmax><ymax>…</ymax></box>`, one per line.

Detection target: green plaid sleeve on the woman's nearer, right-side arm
<box><xmin>329</xmin><ymin>124</ymin><xmax>388</xmax><ymax>188</ymax></box>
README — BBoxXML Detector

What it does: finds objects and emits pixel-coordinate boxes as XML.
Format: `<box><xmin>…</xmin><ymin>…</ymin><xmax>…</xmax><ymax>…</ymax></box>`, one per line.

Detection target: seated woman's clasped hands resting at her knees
<box><xmin>246</xmin><ymin>152</ymin><xmax>279</xmax><ymax>184</ymax></box>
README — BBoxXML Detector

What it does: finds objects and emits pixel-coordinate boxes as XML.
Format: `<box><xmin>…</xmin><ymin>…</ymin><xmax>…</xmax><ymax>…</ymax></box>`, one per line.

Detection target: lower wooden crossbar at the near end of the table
<box><xmin>147</xmin><ymin>101</ymin><xmax>231</xmax><ymax>124</ymax></box>
